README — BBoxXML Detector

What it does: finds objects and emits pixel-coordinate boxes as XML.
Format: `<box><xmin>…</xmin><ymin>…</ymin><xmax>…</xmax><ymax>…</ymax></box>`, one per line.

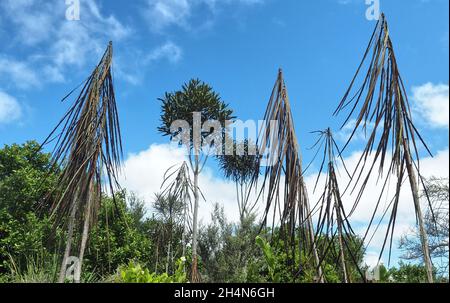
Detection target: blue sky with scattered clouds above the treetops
<box><xmin>0</xmin><ymin>0</ymin><xmax>449</xmax><ymax>270</ymax></box>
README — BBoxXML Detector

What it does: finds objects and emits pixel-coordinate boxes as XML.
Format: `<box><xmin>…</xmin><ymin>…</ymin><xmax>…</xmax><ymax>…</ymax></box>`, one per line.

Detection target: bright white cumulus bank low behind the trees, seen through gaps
<box><xmin>121</xmin><ymin>144</ymin><xmax>449</xmax><ymax>265</ymax></box>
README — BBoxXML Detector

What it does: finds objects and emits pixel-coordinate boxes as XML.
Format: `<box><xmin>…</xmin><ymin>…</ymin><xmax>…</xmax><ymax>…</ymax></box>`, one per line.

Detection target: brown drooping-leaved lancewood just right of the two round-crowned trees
<box><xmin>251</xmin><ymin>69</ymin><xmax>324</xmax><ymax>282</ymax></box>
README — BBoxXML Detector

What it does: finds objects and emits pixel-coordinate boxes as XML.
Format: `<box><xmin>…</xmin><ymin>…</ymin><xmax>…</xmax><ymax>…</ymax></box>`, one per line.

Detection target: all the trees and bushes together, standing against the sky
<box><xmin>0</xmin><ymin>16</ymin><xmax>449</xmax><ymax>283</ymax></box>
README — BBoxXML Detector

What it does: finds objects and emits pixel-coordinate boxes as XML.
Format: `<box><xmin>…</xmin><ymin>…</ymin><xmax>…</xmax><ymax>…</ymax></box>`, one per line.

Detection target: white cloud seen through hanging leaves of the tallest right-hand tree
<box><xmin>305</xmin><ymin>149</ymin><xmax>449</xmax><ymax>265</ymax></box>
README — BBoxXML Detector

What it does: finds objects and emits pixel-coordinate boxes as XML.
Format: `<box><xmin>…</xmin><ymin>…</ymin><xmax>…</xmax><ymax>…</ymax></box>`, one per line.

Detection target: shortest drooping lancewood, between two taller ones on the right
<box><xmin>308</xmin><ymin>128</ymin><xmax>365</xmax><ymax>283</ymax></box>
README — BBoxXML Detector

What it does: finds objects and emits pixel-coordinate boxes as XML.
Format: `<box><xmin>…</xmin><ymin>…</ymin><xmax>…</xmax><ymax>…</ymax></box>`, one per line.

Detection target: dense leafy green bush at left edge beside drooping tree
<box><xmin>0</xmin><ymin>142</ymin><xmax>55</xmax><ymax>274</ymax></box>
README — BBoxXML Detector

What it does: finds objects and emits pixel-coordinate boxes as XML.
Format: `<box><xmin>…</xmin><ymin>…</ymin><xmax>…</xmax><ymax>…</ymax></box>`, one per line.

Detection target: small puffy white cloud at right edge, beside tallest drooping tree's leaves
<box><xmin>412</xmin><ymin>83</ymin><xmax>449</xmax><ymax>128</ymax></box>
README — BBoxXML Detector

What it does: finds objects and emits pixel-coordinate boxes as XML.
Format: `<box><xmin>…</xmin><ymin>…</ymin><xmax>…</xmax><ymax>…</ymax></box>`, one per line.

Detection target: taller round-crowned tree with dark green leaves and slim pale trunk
<box><xmin>158</xmin><ymin>79</ymin><xmax>234</xmax><ymax>282</ymax></box>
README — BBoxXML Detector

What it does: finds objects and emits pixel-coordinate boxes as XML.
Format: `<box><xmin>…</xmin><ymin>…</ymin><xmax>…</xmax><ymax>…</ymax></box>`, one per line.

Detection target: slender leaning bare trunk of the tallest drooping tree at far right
<box><xmin>403</xmin><ymin>144</ymin><xmax>434</xmax><ymax>283</ymax></box>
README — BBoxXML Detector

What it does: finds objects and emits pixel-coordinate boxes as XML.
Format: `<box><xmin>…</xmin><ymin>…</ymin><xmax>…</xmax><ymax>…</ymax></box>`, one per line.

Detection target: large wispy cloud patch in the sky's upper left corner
<box><xmin>0</xmin><ymin>0</ymin><xmax>131</xmax><ymax>88</ymax></box>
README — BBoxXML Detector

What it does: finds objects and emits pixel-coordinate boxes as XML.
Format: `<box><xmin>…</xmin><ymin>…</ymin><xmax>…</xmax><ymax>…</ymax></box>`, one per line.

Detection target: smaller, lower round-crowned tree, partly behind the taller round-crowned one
<box><xmin>218</xmin><ymin>139</ymin><xmax>258</xmax><ymax>224</ymax></box>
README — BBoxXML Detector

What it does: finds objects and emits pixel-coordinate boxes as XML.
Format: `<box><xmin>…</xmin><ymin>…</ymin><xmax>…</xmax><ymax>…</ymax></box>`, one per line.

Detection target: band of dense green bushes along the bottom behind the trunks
<box><xmin>0</xmin><ymin>142</ymin><xmax>442</xmax><ymax>283</ymax></box>
